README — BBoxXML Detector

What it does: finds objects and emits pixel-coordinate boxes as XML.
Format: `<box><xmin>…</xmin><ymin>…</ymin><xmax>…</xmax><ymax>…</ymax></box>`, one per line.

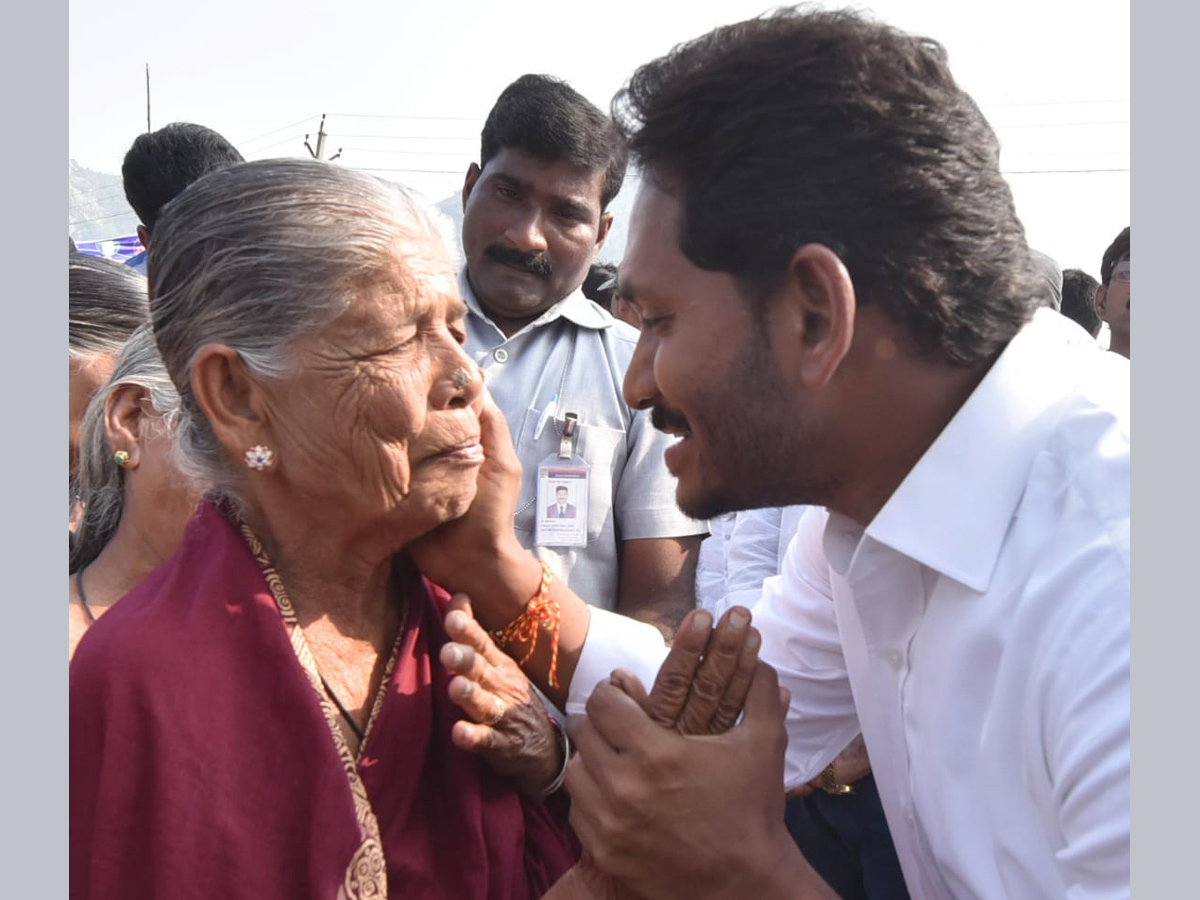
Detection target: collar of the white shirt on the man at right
<box><xmin>865</xmin><ymin>308</ymin><xmax>1094</xmax><ymax>592</ymax></box>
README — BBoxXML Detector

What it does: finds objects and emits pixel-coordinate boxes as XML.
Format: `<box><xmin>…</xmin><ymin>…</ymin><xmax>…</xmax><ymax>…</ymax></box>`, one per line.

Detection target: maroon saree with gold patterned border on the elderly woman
<box><xmin>70</xmin><ymin>502</ymin><xmax>578</xmax><ymax>900</ymax></box>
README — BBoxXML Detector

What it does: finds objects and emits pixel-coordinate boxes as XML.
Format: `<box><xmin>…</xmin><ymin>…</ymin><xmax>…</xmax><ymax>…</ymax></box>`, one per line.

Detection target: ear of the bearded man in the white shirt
<box><xmin>780</xmin><ymin>244</ymin><xmax>856</xmax><ymax>386</ymax></box>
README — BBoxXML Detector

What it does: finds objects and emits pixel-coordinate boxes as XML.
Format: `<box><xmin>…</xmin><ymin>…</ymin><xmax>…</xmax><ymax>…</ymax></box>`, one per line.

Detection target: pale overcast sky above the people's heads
<box><xmin>70</xmin><ymin>0</ymin><xmax>1130</xmax><ymax>275</ymax></box>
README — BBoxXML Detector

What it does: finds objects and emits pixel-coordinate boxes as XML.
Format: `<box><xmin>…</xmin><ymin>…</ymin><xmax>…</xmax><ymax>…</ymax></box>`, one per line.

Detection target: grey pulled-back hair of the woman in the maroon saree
<box><xmin>141</xmin><ymin>160</ymin><xmax>457</xmax><ymax>503</ymax></box>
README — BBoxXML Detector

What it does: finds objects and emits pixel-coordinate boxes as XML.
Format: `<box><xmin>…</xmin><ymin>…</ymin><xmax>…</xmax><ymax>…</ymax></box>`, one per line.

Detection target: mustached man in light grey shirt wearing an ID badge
<box><xmin>460</xmin><ymin>74</ymin><xmax>707</xmax><ymax>634</ymax></box>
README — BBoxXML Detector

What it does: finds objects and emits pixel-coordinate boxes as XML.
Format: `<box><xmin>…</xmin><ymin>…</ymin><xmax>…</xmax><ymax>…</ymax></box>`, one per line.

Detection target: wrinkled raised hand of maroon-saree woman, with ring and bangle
<box><xmin>439</xmin><ymin>594</ymin><xmax>565</xmax><ymax>797</ymax></box>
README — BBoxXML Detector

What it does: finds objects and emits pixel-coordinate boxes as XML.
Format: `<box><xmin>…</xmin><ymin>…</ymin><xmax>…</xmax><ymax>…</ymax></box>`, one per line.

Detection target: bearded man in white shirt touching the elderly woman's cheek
<box><xmin>421</xmin><ymin>10</ymin><xmax>1129</xmax><ymax>900</ymax></box>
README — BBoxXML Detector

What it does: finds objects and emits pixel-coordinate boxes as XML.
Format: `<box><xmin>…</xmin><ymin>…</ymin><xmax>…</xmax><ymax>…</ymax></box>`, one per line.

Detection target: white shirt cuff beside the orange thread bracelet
<box><xmin>566</xmin><ymin>606</ymin><xmax>667</xmax><ymax>715</ymax></box>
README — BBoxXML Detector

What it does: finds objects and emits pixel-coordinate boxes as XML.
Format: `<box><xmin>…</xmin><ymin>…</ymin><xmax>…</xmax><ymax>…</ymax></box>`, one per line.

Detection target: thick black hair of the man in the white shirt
<box><xmin>613</xmin><ymin>8</ymin><xmax>1040</xmax><ymax>365</ymax></box>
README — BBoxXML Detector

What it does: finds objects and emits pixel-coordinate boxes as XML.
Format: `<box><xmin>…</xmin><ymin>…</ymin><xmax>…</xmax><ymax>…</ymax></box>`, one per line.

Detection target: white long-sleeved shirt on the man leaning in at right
<box><xmin>568</xmin><ymin>310</ymin><xmax>1129</xmax><ymax>900</ymax></box>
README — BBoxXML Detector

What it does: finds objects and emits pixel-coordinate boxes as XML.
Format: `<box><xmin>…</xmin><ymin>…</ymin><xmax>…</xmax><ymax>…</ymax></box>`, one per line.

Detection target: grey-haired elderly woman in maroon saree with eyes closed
<box><xmin>70</xmin><ymin>160</ymin><xmax>577</xmax><ymax>900</ymax></box>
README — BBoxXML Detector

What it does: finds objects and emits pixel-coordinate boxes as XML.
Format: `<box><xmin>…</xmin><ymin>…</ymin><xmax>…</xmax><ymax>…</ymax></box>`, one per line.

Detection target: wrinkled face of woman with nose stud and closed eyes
<box><xmin>271</xmin><ymin>242</ymin><xmax>484</xmax><ymax>545</ymax></box>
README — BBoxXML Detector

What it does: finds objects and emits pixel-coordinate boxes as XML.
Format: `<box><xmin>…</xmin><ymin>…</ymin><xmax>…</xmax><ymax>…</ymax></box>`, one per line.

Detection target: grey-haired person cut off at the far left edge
<box><xmin>67</xmin><ymin>253</ymin><xmax>148</xmax><ymax>524</ymax></box>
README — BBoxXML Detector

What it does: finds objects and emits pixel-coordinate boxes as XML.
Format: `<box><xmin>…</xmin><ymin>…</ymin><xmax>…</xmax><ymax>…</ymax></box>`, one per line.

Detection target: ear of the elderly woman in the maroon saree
<box><xmin>192</xmin><ymin>343</ymin><xmax>271</xmax><ymax>457</ymax></box>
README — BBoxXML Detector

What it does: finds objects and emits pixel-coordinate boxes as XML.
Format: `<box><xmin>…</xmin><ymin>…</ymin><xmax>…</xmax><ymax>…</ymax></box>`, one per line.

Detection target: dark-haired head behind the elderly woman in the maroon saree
<box><xmin>121</xmin><ymin>122</ymin><xmax>244</xmax><ymax>275</ymax></box>
